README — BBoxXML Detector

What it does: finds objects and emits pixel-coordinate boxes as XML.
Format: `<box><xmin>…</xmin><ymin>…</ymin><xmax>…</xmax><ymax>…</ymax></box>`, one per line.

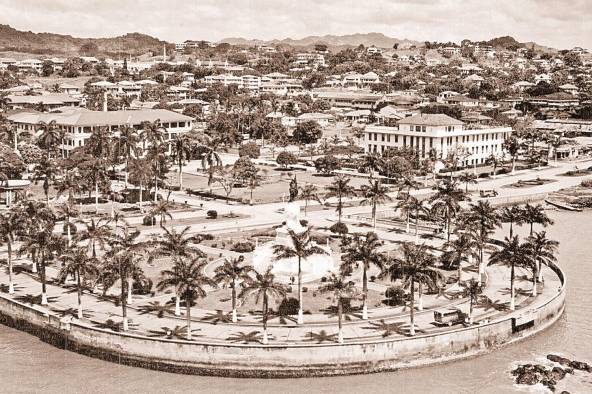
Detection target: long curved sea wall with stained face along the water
<box><xmin>0</xmin><ymin>266</ymin><xmax>566</xmax><ymax>378</ymax></box>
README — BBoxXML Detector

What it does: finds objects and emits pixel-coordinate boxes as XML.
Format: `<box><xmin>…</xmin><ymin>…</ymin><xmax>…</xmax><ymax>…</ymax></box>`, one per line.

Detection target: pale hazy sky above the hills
<box><xmin>0</xmin><ymin>0</ymin><xmax>592</xmax><ymax>49</ymax></box>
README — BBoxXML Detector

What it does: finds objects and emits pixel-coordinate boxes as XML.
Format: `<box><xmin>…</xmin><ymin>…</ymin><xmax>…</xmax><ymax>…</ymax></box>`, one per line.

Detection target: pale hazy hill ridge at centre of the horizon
<box><xmin>221</xmin><ymin>33</ymin><xmax>421</xmax><ymax>48</ymax></box>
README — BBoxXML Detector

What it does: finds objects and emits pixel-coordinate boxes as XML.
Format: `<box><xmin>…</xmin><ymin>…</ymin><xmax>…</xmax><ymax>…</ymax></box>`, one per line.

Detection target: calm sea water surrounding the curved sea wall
<box><xmin>0</xmin><ymin>212</ymin><xmax>592</xmax><ymax>394</ymax></box>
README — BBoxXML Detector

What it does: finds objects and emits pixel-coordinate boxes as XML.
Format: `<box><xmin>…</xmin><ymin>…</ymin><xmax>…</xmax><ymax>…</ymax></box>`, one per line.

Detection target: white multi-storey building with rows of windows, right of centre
<box><xmin>360</xmin><ymin>114</ymin><xmax>512</xmax><ymax>166</ymax></box>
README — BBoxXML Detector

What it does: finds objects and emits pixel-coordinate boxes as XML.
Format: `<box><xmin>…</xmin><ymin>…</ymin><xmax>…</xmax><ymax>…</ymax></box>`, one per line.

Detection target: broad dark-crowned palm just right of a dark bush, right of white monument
<box><xmin>383</xmin><ymin>242</ymin><xmax>438</xmax><ymax>336</ymax></box>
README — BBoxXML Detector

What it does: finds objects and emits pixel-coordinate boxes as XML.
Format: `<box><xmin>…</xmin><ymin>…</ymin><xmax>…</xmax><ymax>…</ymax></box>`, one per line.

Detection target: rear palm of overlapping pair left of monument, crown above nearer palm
<box><xmin>149</xmin><ymin>226</ymin><xmax>205</xmax><ymax>316</ymax></box>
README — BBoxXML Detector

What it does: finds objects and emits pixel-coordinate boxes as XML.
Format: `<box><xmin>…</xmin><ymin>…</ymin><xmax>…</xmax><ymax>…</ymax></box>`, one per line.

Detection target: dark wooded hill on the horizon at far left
<box><xmin>0</xmin><ymin>25</ymin><xmax>170</xmax><ymax>56</ymax></box>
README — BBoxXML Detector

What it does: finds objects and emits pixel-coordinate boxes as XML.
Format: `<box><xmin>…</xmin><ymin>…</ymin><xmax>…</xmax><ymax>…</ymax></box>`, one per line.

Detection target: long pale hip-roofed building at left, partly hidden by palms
<box><xmin>8</xmin><ymin>108</ymin><xmax>193</xmax><ymax>155</ymax></box>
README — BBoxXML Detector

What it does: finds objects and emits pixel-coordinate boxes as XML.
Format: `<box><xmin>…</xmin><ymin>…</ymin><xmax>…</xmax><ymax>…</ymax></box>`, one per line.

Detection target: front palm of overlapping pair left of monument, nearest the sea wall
<box><xmin>157</xmin><ymin>257</ymin><xmax>216</xmax><ymax>341</ymax></box>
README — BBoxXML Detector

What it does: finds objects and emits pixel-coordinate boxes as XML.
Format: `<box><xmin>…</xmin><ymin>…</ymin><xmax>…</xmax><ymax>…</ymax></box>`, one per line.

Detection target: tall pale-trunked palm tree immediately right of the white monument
<box><xmin>341</xmin><ymin>232</ymin><xmax>384</xmax><ymax>320</ymax></box>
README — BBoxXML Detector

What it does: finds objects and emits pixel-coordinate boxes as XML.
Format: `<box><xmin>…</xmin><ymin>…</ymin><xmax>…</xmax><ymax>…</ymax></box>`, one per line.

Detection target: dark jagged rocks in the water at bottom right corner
<box><xmin>512</xmin><ymin>354</ymin><xmax>592</xmax><ymax>394</ymax></box>
